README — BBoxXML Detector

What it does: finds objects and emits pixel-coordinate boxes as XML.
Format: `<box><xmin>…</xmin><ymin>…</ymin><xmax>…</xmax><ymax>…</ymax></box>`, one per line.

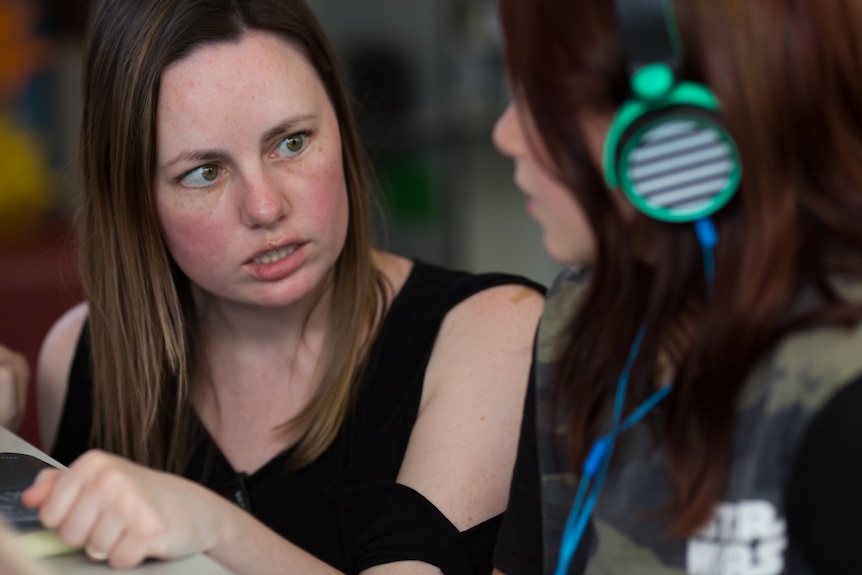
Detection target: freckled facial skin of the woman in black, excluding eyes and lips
<box><xmin>156</xmin><ymin>32</ymin><xmax>348</xmax><ymax>307</ymax></box>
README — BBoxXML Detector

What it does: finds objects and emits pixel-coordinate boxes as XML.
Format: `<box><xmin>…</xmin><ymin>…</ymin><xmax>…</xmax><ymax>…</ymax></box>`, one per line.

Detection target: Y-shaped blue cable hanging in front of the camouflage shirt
<box><xmin>554</xmin><ymin>325</ymin><xmax>671</xmax><ymax>575</ymax></box>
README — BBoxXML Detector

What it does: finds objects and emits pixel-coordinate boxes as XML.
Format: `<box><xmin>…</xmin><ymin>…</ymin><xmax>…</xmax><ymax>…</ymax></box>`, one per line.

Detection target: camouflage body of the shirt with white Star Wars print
<box><xmin>535</xmin><ymin>269</ymin><xmax>862</xmax><ymax>575</ymax></box>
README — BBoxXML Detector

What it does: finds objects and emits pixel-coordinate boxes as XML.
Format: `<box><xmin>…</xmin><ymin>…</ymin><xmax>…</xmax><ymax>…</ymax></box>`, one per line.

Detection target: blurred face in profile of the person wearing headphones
<box><xmin>493</xmin><ymin>99</ymin><xmax>596</xmax><ymax>265</ymax></box>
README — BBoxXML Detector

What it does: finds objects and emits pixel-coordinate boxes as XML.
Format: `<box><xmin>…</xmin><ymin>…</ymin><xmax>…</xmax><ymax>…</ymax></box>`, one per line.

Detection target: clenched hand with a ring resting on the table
<box><xmin>22</xmin><ymin>451</ymin><xmax>232</xmax><ymax>569</ymax></box>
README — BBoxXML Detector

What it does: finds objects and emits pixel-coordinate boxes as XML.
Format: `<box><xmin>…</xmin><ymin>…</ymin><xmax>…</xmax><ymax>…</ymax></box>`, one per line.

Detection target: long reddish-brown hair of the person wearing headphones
<box><xmin>500</xmin><ymin>0</ymin><xmax>862</xmax><ymax>536</ymax></box>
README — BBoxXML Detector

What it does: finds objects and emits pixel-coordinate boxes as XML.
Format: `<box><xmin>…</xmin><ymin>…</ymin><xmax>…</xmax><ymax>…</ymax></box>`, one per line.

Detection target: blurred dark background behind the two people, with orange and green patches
<box><xmin>0</xmin><ymin>0</ymin><xmax>559</xmax><ymax>445</ymax></box>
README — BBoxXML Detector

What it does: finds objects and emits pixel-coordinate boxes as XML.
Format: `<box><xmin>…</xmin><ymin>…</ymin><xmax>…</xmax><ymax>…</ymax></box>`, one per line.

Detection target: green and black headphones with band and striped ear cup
<box><xmin>603</xmin><ymin>0</ymin><xmax>741</xmax><ymax>222</ymax></box>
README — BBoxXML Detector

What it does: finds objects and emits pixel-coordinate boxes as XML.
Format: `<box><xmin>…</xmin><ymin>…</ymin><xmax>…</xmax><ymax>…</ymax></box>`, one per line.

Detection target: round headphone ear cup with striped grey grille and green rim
<box><xmin>613</xmin><ymin>105</ymin><xmax>741</xmax><ymax>222</ymax></box>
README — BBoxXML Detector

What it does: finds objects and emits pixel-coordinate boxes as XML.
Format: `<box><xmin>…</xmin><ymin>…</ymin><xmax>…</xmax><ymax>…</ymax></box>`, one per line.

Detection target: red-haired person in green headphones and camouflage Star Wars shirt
<box><xmin>493</xmin><ymin>0</ymin><xmax>862</xmax><ymax>575</ymax></box>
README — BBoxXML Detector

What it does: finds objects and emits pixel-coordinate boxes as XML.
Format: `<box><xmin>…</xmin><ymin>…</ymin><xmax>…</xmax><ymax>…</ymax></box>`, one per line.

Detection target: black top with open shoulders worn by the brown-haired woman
<box><xmin>51</xmin><ymin>261</ymin><xmax>544</xmax><ymax>575</ymax></box>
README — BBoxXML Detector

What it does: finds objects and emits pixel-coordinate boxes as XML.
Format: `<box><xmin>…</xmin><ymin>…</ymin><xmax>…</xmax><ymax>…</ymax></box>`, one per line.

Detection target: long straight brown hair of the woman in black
<box><xmin>76</xmin><ymin>0</ymin><xmax>386</xmax><ymax>471</ymax></box>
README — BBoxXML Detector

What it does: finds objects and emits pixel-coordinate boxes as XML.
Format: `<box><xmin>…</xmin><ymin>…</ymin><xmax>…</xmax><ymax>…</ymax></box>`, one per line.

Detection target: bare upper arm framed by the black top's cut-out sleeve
<box><xmin>398</xmin><ymin>272</ymin><xmax>543</xmax><ymax>531</ymax></box>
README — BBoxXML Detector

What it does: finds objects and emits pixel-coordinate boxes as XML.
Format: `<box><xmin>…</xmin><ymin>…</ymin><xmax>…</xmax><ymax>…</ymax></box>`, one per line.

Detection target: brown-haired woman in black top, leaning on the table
<box><xmin>15</xmin><ymin>0</ymin><xmax>543</xmax><ymax>575</ymax></box>
